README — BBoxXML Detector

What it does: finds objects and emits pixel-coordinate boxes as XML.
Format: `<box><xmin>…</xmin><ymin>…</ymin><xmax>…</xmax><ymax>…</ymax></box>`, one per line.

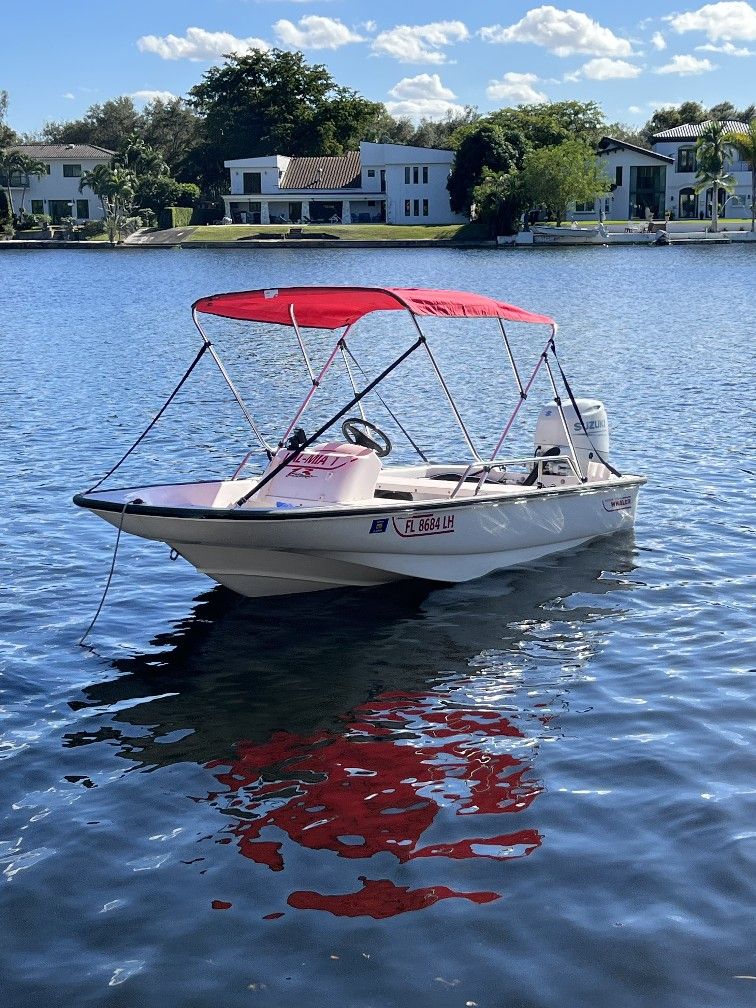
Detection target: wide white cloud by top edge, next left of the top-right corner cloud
<box><xmin>480</xmin><ymin>5</ymin><xmax>633</xmax><ymax>56</ymax></box>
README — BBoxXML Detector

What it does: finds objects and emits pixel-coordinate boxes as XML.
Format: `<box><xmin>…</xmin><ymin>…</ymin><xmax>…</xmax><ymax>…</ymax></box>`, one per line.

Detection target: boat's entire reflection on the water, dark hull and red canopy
<box><xmin>68</xmin><ymin>537</ymin><xmax>634</xmax><ymax>918</ymax></box>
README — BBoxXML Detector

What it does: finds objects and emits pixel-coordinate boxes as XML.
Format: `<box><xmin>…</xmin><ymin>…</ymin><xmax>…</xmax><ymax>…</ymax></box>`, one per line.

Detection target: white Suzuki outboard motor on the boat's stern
<box><xmin>533</xmin><ymin>399</ymin><xmax>609</xmax><ymax>477</ymax></box>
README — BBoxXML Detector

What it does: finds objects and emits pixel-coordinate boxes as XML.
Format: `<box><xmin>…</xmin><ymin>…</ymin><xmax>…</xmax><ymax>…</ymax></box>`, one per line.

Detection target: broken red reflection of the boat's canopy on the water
<box><xmin>208</xmin><ymin>692</ymin><xmax>541</xmax><ymax>918</ymax></box>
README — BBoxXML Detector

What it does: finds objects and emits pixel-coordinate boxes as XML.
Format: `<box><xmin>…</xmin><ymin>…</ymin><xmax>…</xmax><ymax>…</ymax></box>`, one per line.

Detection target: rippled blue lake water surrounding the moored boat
<box><xmin>0</xmin><ymin>247</ymin><xmax>756</xmax><ymax>1008</ymax></box>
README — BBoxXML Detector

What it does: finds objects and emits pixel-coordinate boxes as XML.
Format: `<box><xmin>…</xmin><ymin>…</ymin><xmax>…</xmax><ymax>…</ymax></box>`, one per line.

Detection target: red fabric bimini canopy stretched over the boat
<box><xmin>193</xmin><ymin>287</ymin><xmax>554</xmax><ymax>329</ymax></box>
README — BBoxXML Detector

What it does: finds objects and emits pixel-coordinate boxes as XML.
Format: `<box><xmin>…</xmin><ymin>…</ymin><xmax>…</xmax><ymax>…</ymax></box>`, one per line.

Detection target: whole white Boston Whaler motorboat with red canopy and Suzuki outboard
<box><xmin>74</xmin><ymin>286</ymin><xmax>645</xmax><ymax>597</ymax></box>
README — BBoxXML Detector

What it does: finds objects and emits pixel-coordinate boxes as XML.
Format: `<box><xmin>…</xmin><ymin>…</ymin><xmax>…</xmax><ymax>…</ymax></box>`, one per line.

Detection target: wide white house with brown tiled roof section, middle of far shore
<box><xmin>223</xmin><ymin>143</ymin><xmax>467</xmax><ymax>224</ymax></box>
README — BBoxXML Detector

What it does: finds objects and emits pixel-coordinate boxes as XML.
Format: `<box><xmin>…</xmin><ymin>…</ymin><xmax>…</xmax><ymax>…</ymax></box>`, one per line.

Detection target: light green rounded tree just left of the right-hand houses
<box><xmin>522</xmin><ymin>140</ymin><xmax>610</xmax><ymax>225</ymax></box>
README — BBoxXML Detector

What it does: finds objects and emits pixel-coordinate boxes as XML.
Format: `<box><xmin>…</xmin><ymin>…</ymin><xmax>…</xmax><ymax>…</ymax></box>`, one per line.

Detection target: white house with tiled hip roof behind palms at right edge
<box><xmin>651</xmin><ymin>122</ymin><xmax>751</xmax><ymax>220</ymax></box>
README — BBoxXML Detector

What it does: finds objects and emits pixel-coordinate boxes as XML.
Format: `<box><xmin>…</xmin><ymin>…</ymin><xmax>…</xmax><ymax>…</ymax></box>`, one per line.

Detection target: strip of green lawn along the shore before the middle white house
<box><xmin>185</xmin><ymin>223</ymin><xmax>489</xmax><ymax>242</ymax></box>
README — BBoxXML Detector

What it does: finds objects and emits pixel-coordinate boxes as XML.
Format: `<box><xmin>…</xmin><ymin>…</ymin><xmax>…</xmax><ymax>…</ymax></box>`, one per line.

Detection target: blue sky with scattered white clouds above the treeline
<box><xmin>5</xmin><ymin>0</ymin><xmax>756</xmax><ymax>131</ymax></box>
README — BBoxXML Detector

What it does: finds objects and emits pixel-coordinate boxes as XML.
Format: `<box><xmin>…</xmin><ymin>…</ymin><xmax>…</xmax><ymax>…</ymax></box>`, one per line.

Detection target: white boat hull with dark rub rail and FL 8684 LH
<box><xmin>77</xmin><ymin>476</ymin><xmax>645</xmax><ymax>597</ymax></box>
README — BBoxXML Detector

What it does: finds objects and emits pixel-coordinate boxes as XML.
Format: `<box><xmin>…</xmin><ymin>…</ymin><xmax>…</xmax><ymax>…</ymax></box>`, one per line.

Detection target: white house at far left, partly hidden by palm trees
<box><xmin>3</xmin><ymin>143</ymin><xmax>114</xmax><ymax>224</ymax></box>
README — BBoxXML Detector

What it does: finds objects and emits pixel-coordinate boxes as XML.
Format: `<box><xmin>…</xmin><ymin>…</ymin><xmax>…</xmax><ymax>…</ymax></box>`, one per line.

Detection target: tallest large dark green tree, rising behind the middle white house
<box><xmin>188</xmin><ymin>49</ymin><xmax>382</xmax><ymax>192</ymax></box>
